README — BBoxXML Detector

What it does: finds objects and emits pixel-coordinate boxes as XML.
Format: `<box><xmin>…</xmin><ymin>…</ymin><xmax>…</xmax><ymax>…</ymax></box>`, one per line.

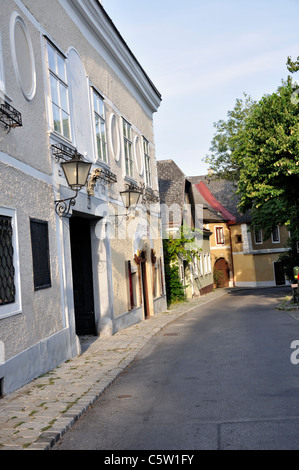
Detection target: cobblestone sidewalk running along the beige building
<box><xmin>0</xmin><ymin>289</ymin><xmax>227</xmax><ymax>450</ymax></box>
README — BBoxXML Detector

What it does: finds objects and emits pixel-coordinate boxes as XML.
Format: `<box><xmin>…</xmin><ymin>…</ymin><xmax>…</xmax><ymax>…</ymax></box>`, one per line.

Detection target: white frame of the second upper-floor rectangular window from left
<box><xmin>91</xmin><ymin>87</ymin><xmax>109</xmax><ymax>165</ymax></box>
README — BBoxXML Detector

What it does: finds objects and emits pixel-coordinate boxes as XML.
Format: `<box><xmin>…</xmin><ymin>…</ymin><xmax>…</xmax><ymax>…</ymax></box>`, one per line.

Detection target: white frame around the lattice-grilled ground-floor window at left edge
<box><xmin>0</xmin><ymin>207</ymin><xmax>22</xmax><ymax>320</ymax></box>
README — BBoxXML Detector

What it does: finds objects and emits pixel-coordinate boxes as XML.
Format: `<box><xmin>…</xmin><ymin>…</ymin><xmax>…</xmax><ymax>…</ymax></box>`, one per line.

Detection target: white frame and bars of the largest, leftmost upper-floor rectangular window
<box><xmin>46</xmin><ymin>40</ymin><xmax>72</xmax><ymax>142</ymax></box>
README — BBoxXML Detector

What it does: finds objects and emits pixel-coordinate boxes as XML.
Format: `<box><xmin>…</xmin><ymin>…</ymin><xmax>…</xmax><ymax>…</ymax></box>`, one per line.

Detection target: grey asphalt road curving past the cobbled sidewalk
<box><xmin>54</xmin><ymin>289</ymin><xmax>299</xmax><ymax>450</ymax></box>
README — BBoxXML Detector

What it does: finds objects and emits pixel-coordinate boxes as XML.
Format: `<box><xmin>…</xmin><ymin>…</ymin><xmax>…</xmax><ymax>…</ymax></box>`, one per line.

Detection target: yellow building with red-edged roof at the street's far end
<box><xmin>189</xmin><ymin>176</ymin><xmax>289</xmax><ymax>287</ymax></box>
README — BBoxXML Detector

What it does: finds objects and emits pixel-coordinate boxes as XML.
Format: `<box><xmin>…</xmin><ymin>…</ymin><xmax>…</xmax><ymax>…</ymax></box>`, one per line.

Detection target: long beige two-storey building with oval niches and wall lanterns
<box><xmin>0</xmin><ymin>0</ymin><xmax>166</xmax><ymax>395</ymax></box>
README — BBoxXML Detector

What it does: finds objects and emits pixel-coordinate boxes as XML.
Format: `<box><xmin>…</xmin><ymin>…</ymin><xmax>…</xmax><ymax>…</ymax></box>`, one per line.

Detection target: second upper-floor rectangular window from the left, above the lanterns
<box><xmin>92</xmin><ymin>89</ymin><xmax>107</xmax><ymax>163</ymax></box>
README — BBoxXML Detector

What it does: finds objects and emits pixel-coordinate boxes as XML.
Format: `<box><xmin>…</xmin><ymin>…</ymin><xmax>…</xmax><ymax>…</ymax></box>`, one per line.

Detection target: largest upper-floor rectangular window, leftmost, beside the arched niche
<box><xmin>48</xmin><ymin>43</ymin><xmax>71</xmax><ymax>140</ymax></box>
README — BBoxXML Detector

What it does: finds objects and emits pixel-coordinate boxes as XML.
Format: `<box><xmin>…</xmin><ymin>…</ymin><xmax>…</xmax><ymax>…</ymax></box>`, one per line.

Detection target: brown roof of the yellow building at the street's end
<box><xmin>188</xmin><ymin>175</ymin><xmax>251</xmax><ymax>223</ymax></box>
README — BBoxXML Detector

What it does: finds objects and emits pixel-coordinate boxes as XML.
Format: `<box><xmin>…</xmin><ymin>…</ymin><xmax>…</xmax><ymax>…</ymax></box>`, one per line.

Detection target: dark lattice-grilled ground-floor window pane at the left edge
<box><xmin>0</xmin><ymin>215</ymin><xmax>16</xmax><ymax>305</ymax></box>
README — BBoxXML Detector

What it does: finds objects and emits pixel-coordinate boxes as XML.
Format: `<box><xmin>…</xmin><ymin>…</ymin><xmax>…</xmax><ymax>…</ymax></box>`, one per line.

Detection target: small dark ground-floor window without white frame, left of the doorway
<box><xmin>30</xmin><ymin>219</ymin><xmax>51</xmax><ymax>290</ymax></box>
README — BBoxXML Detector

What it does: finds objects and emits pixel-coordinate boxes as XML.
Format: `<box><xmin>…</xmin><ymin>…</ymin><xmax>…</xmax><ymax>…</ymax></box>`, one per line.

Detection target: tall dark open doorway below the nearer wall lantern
<box><xmin>70</xmin><ymin>217</ymin><xmax>95</xmax><ymax>335</ymax></box>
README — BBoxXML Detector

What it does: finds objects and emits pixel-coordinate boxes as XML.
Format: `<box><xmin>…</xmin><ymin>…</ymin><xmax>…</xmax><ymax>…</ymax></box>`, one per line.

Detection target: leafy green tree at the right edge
<box><xmin>206</xmin><ymin>68</ymin><xmax>299</xmax><ymax>278</ymax></box>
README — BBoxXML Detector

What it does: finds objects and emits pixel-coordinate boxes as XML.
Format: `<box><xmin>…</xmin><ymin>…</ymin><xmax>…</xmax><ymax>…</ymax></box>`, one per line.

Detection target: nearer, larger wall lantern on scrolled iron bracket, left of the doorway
<box><xmin>55</xmin><ymin>154</ymin><xmax>92</xmax><ymax>217</ymax></box>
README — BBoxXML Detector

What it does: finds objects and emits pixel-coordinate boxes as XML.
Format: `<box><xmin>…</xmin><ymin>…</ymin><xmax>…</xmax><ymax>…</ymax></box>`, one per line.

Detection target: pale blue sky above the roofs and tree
<box><xmin>103</xmin><ymin>0</ymin><xmax>299</xmax><ymax>176</ymax></box>
